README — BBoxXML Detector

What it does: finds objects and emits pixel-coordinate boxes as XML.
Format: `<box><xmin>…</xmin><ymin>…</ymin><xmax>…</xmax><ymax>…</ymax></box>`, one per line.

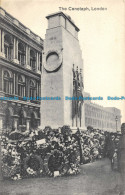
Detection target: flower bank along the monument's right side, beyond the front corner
<box><xmin>76</xmin><ymin>129</ymin><xmax>105</xmax><ymax>164</ymax></box>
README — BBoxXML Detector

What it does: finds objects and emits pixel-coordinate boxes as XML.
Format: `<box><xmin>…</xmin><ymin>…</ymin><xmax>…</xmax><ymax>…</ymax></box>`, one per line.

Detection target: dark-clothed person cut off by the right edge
<box><xmin>118</xmin><ymin>123</ymin><xmax>125</xmax><ymax>195</ymax></box>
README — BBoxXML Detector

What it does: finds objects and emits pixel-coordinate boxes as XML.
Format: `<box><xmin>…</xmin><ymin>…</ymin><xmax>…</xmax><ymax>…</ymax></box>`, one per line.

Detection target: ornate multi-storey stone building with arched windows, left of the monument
<box><xmin>0</xmin><ymin>8</ymin><xmax>43</xmax><ymax>131</ymax></box>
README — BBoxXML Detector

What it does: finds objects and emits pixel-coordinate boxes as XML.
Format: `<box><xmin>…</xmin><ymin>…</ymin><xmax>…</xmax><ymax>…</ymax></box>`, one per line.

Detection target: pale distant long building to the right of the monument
<box><xmin>84</xmin><ymin>93</ymin><xmax>121</xmax><ymax>132</ymax></box>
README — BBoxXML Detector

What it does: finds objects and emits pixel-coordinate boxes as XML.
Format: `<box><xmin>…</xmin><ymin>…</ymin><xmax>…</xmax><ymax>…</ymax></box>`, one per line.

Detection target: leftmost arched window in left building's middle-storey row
<box><xmin>3</xmin><ymin>70</ymin><xmax>13</xmax><ymax>94</ymax></box>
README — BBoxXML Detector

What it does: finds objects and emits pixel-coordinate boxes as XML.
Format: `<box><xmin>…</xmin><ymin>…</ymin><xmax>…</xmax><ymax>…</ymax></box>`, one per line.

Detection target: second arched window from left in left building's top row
<box><xmin>18</xmin><ymin>42</ymin><xmax>26</xmax><ymax>65</ymax></box>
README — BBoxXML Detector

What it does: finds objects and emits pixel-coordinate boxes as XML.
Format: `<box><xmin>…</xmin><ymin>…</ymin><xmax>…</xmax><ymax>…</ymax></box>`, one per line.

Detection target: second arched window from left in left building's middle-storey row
<box><xmin>18</xmin><ymin>75</ymin><xmax>26</xmax><ymax>97</ymax></box>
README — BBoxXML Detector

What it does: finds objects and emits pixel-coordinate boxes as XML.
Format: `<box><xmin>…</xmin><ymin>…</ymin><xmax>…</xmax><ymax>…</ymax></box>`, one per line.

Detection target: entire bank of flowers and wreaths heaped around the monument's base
<box><xmin>1</xmin><ymin>126</ymin><xmax>119</xmax><ymax>180</ymax></box>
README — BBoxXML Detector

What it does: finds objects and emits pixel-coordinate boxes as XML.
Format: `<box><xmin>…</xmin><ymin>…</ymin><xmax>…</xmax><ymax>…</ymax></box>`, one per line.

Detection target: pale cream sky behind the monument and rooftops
<box><xmin>0</xmin><ymin>0</ymin><xmax>125</xmax><ymax>122</ymax></box>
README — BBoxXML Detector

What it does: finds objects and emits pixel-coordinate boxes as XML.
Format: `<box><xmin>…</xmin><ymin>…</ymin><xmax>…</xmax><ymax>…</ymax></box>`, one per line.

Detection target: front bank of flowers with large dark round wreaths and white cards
<box><xmin>1</xmin><ymin>126</ymin><xmax>80</xmax><ymax>180</ymax></box>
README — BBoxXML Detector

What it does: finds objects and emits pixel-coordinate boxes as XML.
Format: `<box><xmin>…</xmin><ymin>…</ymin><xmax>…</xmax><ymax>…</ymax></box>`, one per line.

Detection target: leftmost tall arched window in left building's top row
<box><xmin>4</xmin><ymin>34</ymin><xmax>13</xmax><ymax>60</ymax></box>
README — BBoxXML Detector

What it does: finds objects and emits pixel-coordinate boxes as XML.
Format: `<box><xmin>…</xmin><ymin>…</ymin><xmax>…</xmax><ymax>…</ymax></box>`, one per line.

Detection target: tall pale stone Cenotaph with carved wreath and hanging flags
<box><xmin>41</xmin><ymin>12</ymin><xmax>85</xmax><ymax>129</ymax></box>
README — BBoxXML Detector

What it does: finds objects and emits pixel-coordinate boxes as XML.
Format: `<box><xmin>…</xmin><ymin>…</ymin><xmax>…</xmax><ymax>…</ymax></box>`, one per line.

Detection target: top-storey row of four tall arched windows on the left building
<box><xmin>4</xmin><ymin>34</ymin><xmax>42</xmax><ymax>71</ymax></box>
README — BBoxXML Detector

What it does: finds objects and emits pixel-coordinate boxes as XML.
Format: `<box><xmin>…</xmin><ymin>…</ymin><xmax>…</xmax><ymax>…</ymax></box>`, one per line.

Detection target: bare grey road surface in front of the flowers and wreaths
<box><xmin>0</xmin><ymin>159</ymin><xmax>121</xmax><ymax>195</ymax></box>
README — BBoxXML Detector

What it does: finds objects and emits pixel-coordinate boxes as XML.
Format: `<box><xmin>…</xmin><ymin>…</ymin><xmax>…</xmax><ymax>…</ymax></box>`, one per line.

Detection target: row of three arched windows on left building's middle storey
<box><xmin>3</xmin><ymin>70</ymin><xmax>39</xmax><ymax>97</ymax></box>
